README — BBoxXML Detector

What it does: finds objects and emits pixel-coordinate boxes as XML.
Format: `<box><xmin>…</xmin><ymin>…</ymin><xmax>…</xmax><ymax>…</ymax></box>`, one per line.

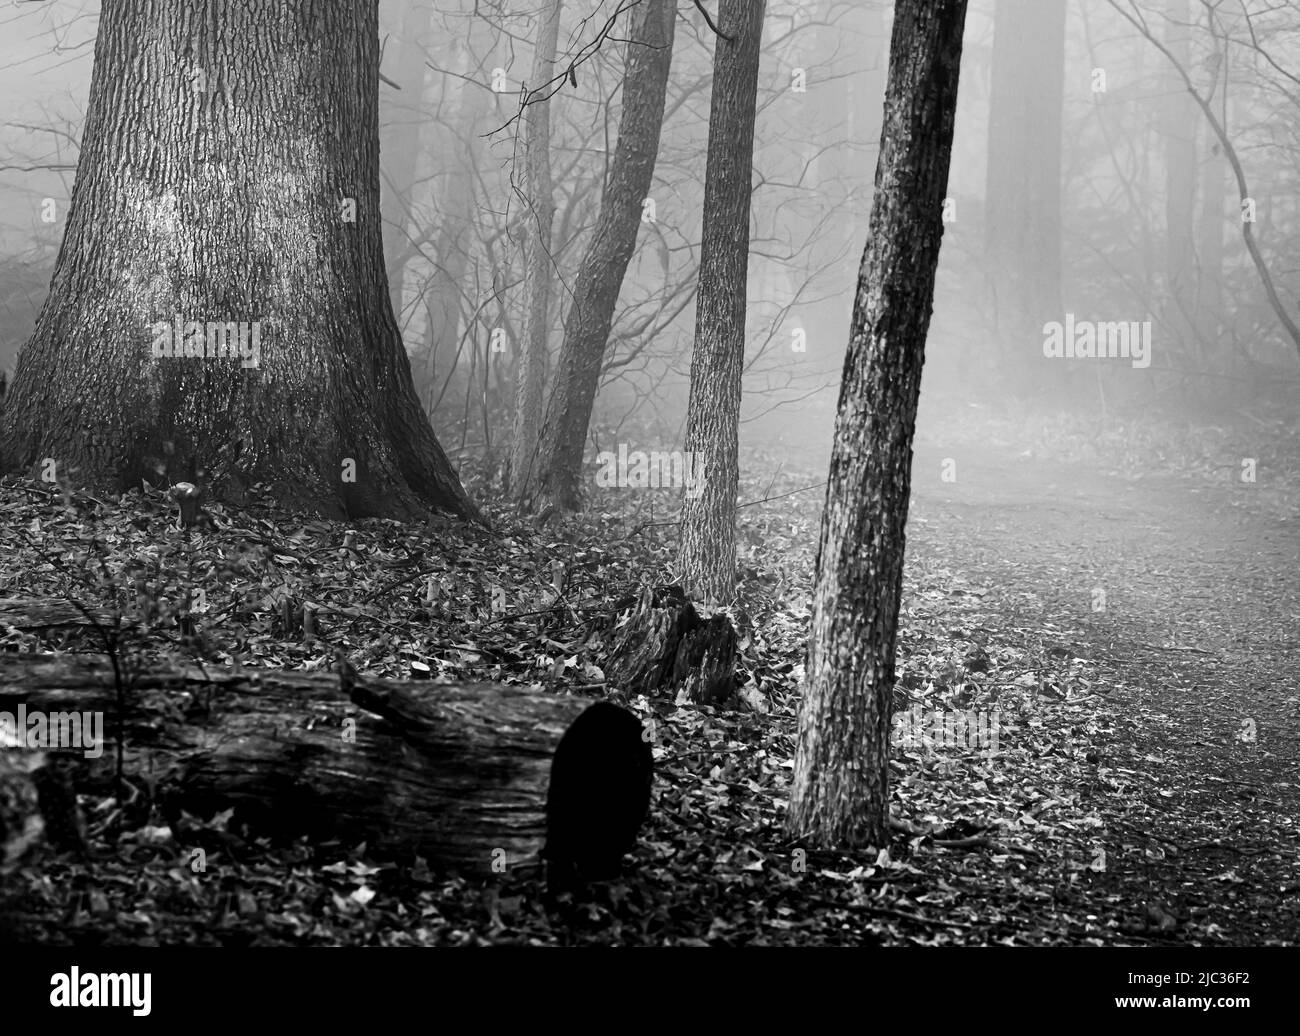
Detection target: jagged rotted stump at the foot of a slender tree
<box><xmin>605</xmin><ymin>586</ymin><xmax>736</xmax><ymax>705</ymax></box>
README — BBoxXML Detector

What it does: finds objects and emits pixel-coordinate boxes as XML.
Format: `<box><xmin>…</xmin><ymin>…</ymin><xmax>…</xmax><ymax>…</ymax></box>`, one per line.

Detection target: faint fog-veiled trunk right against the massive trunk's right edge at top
<box><xmin>380</xmin><ymin>3</ymin><xmax>433</xmax><ymax>315</ymax></box>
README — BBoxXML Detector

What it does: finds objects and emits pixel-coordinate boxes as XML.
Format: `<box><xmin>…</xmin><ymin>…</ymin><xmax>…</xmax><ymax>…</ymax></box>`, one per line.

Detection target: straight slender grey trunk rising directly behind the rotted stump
<box><xmin>677</xmin><ymin>0</ymin><xmax>766</xmax><ymax>603</ymax></box>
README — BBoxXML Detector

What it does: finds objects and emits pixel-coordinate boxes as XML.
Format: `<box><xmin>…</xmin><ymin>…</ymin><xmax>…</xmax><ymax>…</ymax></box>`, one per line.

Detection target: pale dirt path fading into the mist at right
<box><xmin>909</xmin><ymin>445</ymin><xmax>1300</xmax><ymax>944</ymax></box>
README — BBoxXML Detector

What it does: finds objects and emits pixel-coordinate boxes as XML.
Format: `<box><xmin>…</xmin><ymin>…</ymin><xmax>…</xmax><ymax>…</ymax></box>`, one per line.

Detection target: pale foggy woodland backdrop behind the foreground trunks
<box><xmin>0</xmin><ymin>0</ymin><xmax>1300</xmax><ymax>480</ymax></box>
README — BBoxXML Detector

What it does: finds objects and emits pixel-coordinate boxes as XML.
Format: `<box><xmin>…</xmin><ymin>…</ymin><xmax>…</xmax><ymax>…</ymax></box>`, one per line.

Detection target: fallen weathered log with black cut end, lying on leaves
<box><xmin>0</xmin><ymin>654</ymin><xmax>647</xmax><ymax>875</ymax></box>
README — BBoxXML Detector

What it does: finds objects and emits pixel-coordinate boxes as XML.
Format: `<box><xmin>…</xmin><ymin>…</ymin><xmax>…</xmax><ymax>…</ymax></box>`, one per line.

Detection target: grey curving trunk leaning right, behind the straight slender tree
<box><xmin>519</xmin><ymin>0</ymin><xmax>677</xmax><ymax>511</ymax></box>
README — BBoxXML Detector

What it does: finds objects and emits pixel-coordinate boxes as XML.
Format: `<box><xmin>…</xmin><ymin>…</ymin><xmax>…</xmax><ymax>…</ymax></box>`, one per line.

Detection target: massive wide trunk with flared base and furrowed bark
<box><xmin>0</xmin><ymin>0</ymin><xmax>477</xmax><ymax>517</ymax></box>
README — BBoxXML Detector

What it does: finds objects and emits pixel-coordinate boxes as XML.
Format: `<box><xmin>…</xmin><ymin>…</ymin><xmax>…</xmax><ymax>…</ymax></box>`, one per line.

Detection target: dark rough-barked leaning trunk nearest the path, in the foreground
<box><xmin>787</xmin><ymin>0</ymin><xmax>966</xmax><ymax>848</ymax></box>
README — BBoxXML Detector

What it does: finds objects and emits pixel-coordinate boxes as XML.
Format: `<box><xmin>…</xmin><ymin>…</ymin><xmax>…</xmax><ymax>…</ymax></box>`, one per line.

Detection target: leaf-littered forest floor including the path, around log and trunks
<box><xmin>0</xmin><ymin>397</ymin><xmax>1300</xmax><ymax>945</ymax></box>
